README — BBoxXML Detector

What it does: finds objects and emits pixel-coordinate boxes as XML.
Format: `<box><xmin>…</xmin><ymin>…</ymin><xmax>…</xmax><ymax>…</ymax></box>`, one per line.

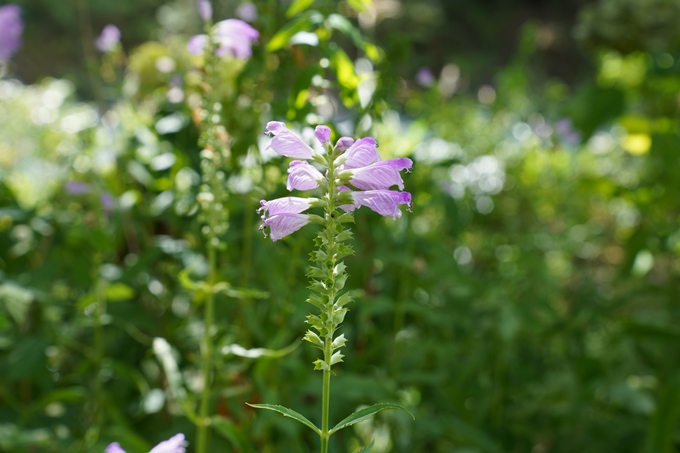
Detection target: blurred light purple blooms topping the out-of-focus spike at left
<box><xmin>187</xmin><ymin>19</ymin><xmax>260</xmax><ymax>58</ymax></box>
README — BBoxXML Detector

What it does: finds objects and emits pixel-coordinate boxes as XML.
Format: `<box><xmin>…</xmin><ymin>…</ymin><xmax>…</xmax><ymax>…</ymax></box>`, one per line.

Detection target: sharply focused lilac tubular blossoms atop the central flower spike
<box><xmin>260</xmin><ymin>121</ymin><xmax>413</xmax><ymax>241</ymax></box>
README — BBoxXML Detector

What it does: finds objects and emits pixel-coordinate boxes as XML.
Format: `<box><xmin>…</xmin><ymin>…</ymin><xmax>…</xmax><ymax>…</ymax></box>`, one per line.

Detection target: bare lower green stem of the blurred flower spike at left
<box><xmin>196</xmin><ymin>237</ymin><xmax>216</xmax><ymax>453</ymax></box>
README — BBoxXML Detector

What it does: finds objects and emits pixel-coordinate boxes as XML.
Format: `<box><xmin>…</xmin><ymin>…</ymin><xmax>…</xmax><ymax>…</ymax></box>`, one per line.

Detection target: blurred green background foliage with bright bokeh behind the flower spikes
<box><xmin>0</xmin><ymin>0</ymin><xmax>680</xmax><ymax>453</ymax></box>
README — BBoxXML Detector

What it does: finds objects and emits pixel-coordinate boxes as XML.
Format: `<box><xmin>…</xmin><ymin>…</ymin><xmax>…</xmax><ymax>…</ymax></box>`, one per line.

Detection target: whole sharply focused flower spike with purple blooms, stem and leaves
<box><xmin>252</xmin><ymin>122</ymin><xmax>413</xmax><ymax>453</ymax></box>
